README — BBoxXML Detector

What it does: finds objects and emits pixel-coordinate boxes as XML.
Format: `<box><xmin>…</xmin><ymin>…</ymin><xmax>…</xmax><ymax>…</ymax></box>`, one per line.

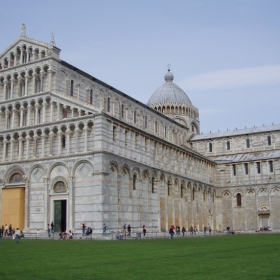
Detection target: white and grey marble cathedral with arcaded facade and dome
<box><xmin>0</xmin><ymin>24</ymin><xmax>280</xmax><ymax>233</ymax></box>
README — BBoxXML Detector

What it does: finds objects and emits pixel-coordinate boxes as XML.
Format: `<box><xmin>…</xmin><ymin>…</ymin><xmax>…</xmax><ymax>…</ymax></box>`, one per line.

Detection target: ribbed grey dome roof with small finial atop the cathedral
<box><xmin>147</xmin><ymin>69</ymin><xmax>192</xmax><ymax>106</ymax></box>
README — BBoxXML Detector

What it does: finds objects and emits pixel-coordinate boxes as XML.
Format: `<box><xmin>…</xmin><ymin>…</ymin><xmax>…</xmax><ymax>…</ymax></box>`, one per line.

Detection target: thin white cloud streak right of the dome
<box><xmin>181</xmin><ymin>64</ymin><xmax>280</xmax><ymax>91</ymax></box>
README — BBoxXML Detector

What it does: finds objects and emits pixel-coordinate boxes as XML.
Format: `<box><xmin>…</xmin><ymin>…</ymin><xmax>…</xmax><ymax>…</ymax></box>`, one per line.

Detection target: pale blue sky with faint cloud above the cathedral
<box><xmin>0</xmin><ymin>0</ymin><xmax>280</xmax><ymax>133</ymax></box>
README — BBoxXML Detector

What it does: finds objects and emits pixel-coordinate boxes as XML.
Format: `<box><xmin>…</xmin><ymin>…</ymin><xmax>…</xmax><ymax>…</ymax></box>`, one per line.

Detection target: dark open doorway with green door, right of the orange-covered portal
<box><xmin>54</xmin><ymin>200</ymin><xmax>67</xmax><ymax>232</ymax></box>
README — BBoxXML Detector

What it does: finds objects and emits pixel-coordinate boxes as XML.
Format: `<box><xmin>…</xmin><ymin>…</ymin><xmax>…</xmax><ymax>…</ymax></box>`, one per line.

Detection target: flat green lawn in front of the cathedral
<box><xmin>0</xmin><ymin>234</ymin><xmax>280</xmax><ymax>280</ymax></box>
